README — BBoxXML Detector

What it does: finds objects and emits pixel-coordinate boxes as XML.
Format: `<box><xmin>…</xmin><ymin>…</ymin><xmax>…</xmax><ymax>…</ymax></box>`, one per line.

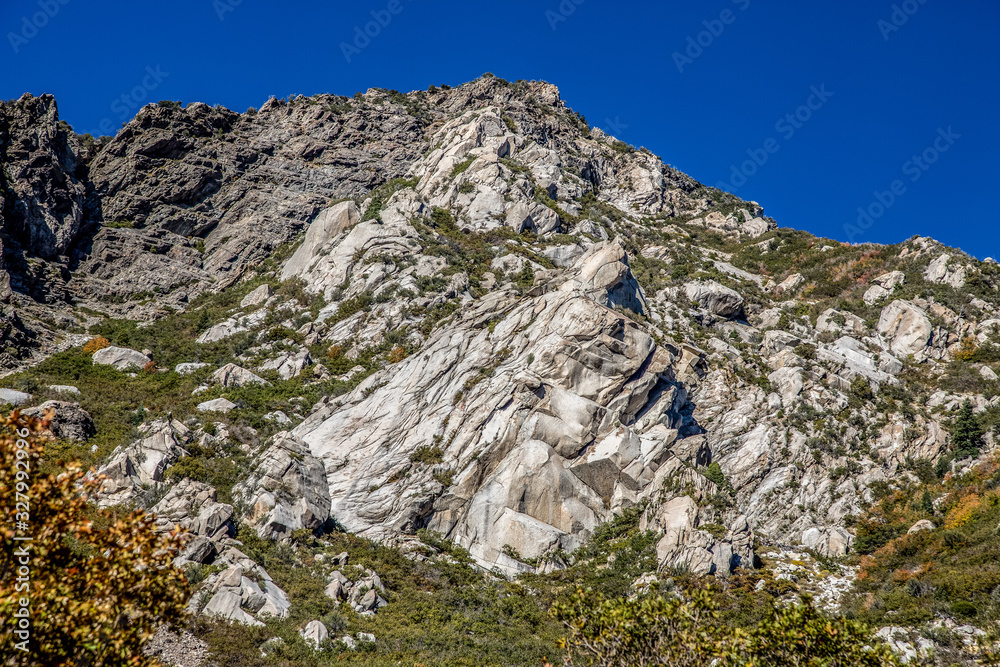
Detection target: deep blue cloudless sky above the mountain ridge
<box><xmin>0</xmin><ymin>0</ymin><xmax>1000</xmax><ymax>258</ymax></box>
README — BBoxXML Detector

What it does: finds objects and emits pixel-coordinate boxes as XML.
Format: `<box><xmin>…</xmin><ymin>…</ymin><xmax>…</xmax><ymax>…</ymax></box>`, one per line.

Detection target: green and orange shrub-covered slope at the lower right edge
<box><xmin>846</xmin><ymin>457</ymin><xmax>1000</xmax><ymax>627</ymax></box>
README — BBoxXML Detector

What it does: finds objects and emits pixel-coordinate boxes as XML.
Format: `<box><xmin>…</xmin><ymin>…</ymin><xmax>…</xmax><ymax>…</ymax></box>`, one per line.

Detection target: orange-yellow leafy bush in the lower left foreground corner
<box><xmin>0</xmin><ymin>410</ymin><xmax>188</xmax><ymax>667</ymax></box>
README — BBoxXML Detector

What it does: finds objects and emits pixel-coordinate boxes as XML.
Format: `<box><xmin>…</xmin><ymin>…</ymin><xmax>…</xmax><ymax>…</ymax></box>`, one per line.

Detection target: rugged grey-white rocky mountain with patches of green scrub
<box><xmin>0</xmin><ymin>75</ymin><xmax>1000</xmax><ymax>664</ymax></box>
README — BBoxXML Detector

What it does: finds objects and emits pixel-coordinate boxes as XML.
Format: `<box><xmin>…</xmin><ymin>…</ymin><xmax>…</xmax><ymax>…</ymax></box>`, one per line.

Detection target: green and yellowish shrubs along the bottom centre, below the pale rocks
<box><xmin>182</xmin><ymin>508</ymin><xmax>908</xmax><ymax>667</ymax></box>
